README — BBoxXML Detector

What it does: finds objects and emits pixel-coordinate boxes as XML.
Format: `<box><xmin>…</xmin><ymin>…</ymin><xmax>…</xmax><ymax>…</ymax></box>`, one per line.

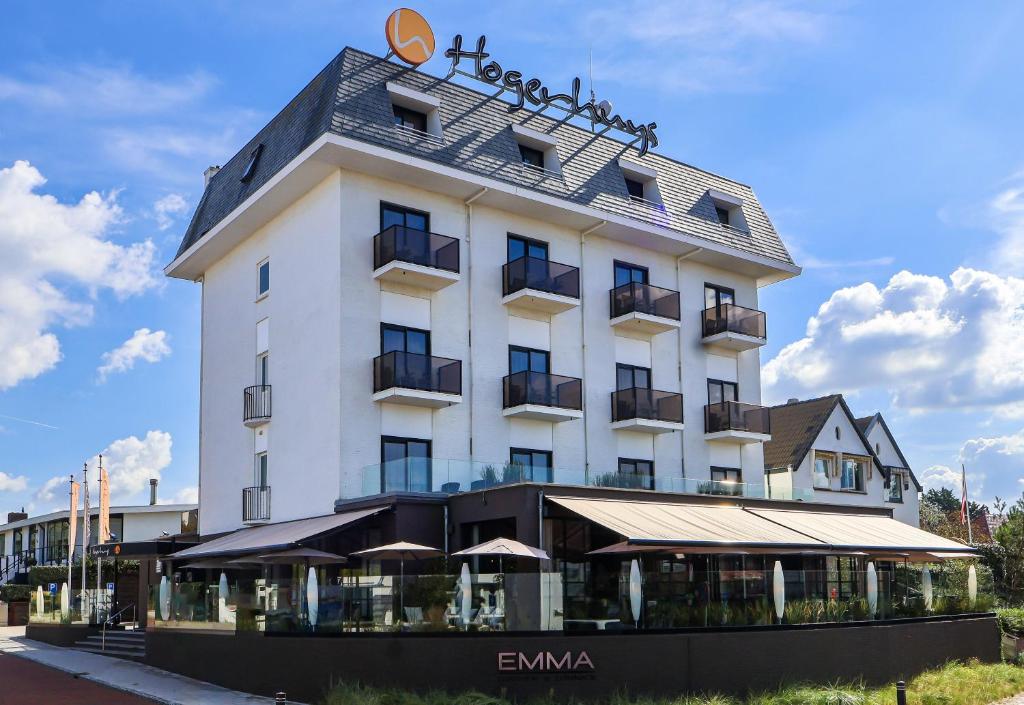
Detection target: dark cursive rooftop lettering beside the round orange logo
<box><xmin>444</xmin><ymin>34</ymin><xmax>657</xmax><ymax>156</ymax></box>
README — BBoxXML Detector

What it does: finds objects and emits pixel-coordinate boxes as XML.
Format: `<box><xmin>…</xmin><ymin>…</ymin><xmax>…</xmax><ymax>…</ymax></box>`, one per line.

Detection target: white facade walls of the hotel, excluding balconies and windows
<box><xmin>200</xmin><ymin>171</ymin><xmax>763</xmax><ymax>535</ymax></box>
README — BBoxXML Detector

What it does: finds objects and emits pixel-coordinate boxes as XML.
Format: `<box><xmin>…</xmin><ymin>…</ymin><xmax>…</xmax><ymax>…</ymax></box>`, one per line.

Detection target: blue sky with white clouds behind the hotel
<box><xmin>0</xmin><ymin>0</ymin><xmax>1024</xmax><ymax>518</ymax></box>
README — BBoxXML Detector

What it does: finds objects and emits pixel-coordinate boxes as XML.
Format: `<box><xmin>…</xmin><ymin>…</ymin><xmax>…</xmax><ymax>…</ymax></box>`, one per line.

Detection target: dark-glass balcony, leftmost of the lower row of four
<box><xmin>373</xmin><ymin>350</ymin><xmax>462</xmax><ymax>409</ymax></box>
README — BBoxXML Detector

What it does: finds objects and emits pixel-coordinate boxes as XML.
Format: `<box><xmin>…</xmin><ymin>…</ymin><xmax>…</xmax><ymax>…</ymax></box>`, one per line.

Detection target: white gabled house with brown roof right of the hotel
<box><xmin>765</xmin><ymin>395</ymin><xmax>920</xmax><ymax>526</ymax></box>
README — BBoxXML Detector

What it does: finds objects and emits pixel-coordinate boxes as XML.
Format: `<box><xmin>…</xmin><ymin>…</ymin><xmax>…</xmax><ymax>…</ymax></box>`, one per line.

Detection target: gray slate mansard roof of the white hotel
<box><xmin>178</xmin><ymin>47</ymin><xmax>793</xmax><ymax>264</ymax></box>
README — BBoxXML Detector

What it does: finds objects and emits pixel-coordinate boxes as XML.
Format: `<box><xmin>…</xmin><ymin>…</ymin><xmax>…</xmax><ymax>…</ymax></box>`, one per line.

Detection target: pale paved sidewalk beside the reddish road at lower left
<box><xmin>0</xmin><ymin>627</ymin><xmax>296</xmax><ymax>705</ymax></box>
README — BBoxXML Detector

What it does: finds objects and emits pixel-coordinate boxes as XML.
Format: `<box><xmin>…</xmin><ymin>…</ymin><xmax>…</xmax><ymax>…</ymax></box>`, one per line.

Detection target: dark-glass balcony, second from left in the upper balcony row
<box><xmin>502</xmin><ymin>257</ymin><xmax>580</xmax><ymax>316</ymax></box>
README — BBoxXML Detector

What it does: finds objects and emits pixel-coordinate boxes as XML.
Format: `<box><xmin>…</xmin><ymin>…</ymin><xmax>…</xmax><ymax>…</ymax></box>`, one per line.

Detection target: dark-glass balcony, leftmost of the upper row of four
<box><xmin>374</xmin><ymin>225</ymin><xmax>459</xmax><ymax>291</ymax></box>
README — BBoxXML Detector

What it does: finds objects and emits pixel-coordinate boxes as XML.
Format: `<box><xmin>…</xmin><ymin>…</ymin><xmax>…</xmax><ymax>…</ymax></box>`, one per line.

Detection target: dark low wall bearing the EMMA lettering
<box><xmin>146</xmin><ymin>615</ymin><xmax>999</xmax><ymax>703</ymax></box>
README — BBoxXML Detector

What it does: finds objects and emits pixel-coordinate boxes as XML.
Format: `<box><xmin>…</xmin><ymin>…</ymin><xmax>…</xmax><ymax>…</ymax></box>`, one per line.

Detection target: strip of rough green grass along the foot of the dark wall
<box><xmin>323</xmin><ymin>663</ymin><xmax>1024</xmax><ymax>705</ymax></box>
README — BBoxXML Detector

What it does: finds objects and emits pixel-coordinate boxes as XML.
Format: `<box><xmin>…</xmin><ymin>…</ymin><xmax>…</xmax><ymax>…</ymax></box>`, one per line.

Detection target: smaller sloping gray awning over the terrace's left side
<box><xmin>167</xmin><ymin>507</ymin><xmax>387</xmax><ymax>561</ymax></box>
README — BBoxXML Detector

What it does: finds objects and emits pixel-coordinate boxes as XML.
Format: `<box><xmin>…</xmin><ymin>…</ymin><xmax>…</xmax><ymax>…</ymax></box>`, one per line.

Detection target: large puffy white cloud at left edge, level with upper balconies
<box><xmin>0</xmin><ymin>161</ymin><xmax>158</xmax><ymax>389</ymax></box>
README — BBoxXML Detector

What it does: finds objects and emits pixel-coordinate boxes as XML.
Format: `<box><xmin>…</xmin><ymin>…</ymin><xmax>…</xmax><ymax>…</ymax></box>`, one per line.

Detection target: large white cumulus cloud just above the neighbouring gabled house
<box><xmin>764</xmin><ymin>267</ymin><xmax>1024</xmax><ymax>416</ymax></box>
